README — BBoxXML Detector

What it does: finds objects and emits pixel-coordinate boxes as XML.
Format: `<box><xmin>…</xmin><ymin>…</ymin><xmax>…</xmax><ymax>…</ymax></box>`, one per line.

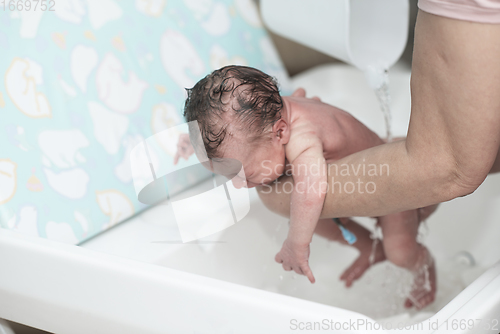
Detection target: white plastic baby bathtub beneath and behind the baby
<box><xmin>0</xmin><ymin>66</ymin><xmax>500</xmax><ymax>334</ymax></box>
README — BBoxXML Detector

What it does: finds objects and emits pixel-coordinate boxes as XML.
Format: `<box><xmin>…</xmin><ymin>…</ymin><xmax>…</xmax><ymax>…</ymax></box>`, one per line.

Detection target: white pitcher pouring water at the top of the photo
<box><xmin>261</xmin><ymin>0</ymin><xmax>409</xmax><ymax>70</ymax></box>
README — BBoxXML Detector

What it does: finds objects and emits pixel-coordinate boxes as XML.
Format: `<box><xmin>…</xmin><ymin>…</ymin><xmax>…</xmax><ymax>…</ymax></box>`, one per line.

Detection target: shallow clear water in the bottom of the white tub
<box><xmin>260</xmin><ymin>218</ymin><xmax>484</xmax><ymax>320</ymax></box>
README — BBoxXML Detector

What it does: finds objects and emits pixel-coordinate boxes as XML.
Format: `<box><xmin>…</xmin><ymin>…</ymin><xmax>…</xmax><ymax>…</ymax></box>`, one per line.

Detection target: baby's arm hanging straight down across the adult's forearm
<box><xmin>275</xmin><ymin>133</ymin><xmax>327</xmax><ymax>283</ymax></box>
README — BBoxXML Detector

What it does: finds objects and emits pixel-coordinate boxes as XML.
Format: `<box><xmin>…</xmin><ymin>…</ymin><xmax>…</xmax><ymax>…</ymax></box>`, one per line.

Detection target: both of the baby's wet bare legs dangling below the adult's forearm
<box><xmin>315</xmin><ymin>205</ymin><xmax>437</xmax><ymax>308</ymax></box>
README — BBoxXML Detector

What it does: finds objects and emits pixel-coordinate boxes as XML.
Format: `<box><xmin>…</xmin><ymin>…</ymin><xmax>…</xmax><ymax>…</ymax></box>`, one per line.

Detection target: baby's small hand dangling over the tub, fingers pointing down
<box><xmin>274</xmin><ymin>238</ymin><xmax>316</xmax><ymax>283</ymax></box>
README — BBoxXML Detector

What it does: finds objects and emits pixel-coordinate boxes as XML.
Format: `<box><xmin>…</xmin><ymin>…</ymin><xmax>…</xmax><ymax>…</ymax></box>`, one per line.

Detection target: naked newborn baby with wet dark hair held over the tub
<box><xmin>181</xmin><ymin>66</ymin><xmax>436</xmax><ymax>308</ymax></box>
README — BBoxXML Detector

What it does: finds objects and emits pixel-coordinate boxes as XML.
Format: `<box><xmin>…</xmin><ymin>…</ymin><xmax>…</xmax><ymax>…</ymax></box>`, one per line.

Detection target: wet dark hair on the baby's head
<box><xmin>184</xmin><ymin>65</ymin><xmax>283</xmax><ymax>158</ymax></box>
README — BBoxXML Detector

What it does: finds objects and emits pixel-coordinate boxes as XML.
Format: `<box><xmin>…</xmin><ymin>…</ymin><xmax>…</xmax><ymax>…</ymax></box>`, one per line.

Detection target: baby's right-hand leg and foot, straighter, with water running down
<box><xmin>379</xmin><ymin>209</ymin><xmax>436</xmax><ymax>309</ymax></box>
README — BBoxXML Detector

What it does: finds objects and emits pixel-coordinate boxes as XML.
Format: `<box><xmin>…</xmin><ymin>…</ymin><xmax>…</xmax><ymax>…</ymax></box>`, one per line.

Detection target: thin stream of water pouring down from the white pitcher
<box><xmin>365</xmin><ymin>67</ymin><xmax>392</xmax><ymax>143</ymax></box>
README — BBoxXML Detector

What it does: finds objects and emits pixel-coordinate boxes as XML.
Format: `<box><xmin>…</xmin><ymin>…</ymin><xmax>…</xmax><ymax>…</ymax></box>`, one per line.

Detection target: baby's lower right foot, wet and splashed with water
<box><xmin>405</xmin><ymin>246</ymin><xmax>436</xmax><ymax>310</ymax></box>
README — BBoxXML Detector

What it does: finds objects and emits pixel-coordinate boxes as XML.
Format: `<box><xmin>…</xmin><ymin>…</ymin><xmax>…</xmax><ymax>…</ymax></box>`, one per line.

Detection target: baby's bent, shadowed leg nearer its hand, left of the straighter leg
<box><xmin>314</xmin><ymin>218</ymin><xmax>385</xmax><ymax>287</ymax></box>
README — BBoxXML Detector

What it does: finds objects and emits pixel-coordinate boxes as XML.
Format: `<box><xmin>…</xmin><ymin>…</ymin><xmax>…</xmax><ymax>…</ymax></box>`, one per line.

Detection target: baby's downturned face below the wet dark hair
<box><xmin>219</xmin><ymin>136</ymin><xmax>285</xmax><ymax>188</ymax></box>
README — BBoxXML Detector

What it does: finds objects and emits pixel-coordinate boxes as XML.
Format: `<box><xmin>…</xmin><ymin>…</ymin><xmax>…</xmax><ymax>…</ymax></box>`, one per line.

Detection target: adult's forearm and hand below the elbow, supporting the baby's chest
<box><xmin>257</xmin><ymin>141</ymin><xmax>457</xmax><ymax>218</ymax></box>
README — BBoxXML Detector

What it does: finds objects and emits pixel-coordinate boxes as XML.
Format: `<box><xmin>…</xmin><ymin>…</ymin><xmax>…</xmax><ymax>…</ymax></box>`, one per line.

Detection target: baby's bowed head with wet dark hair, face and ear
<box><xmin>184</xmin><ymin>66</ymin><xmax>290</xmax><ymax>188</ymax></box>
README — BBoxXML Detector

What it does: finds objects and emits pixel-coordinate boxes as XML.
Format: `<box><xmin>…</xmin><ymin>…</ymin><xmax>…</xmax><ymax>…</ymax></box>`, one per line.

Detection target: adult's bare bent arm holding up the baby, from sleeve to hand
<box><xmin>259</xmin><ymin>11</ymin><xmax>500</xmax><ymax>217</ymax></box>
